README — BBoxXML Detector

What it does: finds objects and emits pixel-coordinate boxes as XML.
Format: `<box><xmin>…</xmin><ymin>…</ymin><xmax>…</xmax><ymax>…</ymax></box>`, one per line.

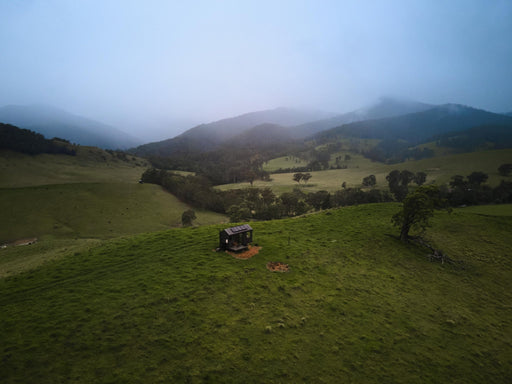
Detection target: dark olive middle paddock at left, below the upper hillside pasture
<box><xmin>0</xmin><ymin>183</ymin><xmax>221</xmax><ymax>242</ymax></box>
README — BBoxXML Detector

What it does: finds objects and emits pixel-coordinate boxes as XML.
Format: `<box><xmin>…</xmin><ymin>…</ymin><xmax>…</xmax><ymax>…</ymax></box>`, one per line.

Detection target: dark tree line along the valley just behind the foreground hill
<box><xmin>142</xmin><ymin>166</ymin><xmax>512</xmax><ymax>222</ymax></box>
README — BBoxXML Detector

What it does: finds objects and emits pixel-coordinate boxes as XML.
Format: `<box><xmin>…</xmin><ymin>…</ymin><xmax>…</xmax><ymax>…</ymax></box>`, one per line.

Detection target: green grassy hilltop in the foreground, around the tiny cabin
<box><xmin>0</xmin><ymin>204</ymin><xmax>512</xmax><ymax>383</ymax></box>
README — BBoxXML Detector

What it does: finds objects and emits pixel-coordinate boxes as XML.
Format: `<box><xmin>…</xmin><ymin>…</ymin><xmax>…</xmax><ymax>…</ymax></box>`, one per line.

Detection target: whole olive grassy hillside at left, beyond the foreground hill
<box><xmin>0</xmin><ymin>147</ymin><xmax>225</xmax><ymax>277</ymax></box>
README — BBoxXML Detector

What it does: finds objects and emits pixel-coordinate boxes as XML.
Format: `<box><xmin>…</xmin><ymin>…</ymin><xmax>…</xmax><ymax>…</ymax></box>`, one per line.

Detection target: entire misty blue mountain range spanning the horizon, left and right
<box><xmin>4</xmin><ymin>97</ymin><xmax>512</xmax><ymax>157</ymax></box>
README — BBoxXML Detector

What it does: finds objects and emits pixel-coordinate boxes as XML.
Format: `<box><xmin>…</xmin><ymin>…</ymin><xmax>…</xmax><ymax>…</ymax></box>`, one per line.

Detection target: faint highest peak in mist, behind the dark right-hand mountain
<box><xmin>293</xmin><ymin>97</ymin><xmax>433</xmax><ymax>138</ymax></box>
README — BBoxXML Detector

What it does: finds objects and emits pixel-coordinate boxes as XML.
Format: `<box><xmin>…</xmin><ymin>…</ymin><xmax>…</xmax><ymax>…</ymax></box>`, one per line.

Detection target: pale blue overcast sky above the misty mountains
<box><xmin>0</xmin><ymin>0</ymin><xmax>512</xmax><ymax>140</ymax></box>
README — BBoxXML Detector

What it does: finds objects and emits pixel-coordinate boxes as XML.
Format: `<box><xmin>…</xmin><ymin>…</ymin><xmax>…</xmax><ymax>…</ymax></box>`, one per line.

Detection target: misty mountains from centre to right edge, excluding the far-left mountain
<box><xmin>133</xmin><ymin>97</ymin><xmax>512</xmax><ymax>157</ymax></box>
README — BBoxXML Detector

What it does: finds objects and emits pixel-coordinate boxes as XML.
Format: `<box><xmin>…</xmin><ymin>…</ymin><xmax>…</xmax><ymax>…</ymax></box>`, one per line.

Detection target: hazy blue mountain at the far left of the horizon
<box><xmin>0</xmin><ymin>105</ymin><xmax>140</xmax><ymax>149</ymax></box>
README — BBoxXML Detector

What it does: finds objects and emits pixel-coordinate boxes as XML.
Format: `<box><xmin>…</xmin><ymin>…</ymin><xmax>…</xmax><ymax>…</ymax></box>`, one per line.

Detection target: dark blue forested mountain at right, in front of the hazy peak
<box><xmin>315</xmin><ymin>104</ymin><xmax>512</xmax><ymax>145</ymax></box>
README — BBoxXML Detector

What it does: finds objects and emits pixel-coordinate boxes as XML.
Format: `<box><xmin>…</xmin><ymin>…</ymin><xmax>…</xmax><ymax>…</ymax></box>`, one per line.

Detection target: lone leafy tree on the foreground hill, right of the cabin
<box><xmin>391</xmin><ymin>185</ymin><xmax>443</xmax><ymax>242</ymax></box>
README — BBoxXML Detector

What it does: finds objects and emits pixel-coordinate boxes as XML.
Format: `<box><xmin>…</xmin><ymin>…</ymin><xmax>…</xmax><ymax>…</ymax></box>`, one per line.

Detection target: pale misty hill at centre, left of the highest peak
<box><xmin>133</xmin><ymin>108</ymin><xmax>329</xmax><ymax>156</ymax></box>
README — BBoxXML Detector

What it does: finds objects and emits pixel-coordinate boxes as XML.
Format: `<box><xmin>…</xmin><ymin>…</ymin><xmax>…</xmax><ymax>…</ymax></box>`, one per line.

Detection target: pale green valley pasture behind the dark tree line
<box><xmin>218</xmin><ymin>149</ymin><xmax>512</xmax><ymax>194</ymax></box>
